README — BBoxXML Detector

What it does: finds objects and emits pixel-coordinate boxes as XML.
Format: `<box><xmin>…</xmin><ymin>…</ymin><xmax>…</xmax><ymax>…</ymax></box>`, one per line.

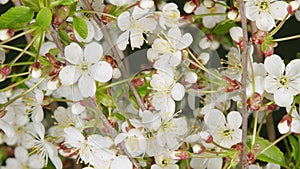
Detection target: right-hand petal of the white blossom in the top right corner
<box><xmin>270</xmin><ymin>1</ymin><xmax>288</xmax><ymax>20</ymax></box>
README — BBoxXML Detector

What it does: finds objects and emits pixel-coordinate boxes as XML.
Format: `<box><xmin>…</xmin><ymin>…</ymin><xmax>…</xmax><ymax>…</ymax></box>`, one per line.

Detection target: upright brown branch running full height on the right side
<box><xmin>238</xmin><ymin>0</ymin><xmax>249</xmax><ymax>169</ymax></box>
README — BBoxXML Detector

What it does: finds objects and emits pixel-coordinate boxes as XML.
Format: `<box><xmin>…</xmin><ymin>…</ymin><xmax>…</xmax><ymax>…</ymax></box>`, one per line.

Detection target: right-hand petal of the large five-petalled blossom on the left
<box><xmin>92</xmin><ymin>61</ymin><xmax>113</xmax><ymax>82</ymax></box>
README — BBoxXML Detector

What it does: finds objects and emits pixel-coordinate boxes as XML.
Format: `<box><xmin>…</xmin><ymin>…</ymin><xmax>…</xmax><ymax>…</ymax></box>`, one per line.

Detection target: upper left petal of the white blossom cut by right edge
<box><xmin>264</xmin><ymin>55</ymin><xmax>285</xmax><ymax>77</ymax></box>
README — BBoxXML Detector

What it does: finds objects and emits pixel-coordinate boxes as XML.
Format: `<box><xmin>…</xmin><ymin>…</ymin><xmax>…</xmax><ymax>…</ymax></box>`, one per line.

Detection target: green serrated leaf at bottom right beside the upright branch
<box><xmin>247</xmin><ymin>136</ymin><xmax>287</xmax><ymax>167</ymax></box>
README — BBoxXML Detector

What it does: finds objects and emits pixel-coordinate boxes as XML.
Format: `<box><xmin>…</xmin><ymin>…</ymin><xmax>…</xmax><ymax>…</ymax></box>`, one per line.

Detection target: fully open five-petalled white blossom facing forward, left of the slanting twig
<box><xmin>59</xmin><ymin>42</ymin><xmax>113</xmax><ymax>97</ymax></box>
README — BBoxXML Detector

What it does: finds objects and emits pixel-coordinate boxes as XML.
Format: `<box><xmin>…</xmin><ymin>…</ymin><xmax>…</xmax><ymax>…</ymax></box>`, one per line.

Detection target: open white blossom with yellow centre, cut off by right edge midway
<box><xmin>264</xmin><ymin>54</ymin><xmax>300</xmax><ymax>107</ymax></box>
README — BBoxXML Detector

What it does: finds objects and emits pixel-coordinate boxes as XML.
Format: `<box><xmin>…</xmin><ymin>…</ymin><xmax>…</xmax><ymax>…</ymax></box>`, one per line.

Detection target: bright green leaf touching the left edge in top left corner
<box><xmin>0</xmin><ymin>6</ymin><xmax>34</xmax><ymax>29</ymax></box>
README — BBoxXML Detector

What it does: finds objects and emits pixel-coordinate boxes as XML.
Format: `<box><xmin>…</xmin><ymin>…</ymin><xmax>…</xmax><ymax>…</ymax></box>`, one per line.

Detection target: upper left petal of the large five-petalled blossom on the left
<box><xmin>65</xmin><ymin>42</ymin><xmax>83</xmax><ymax>65</ymax></box>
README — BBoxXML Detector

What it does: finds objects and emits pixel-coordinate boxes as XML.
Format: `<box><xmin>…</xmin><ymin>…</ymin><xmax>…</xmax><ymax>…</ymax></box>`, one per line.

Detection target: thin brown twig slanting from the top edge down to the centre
<box><xmin>84</xmin><ymin>0</ymin><xmax>146</xmax><ymax>111</ymax></box>
